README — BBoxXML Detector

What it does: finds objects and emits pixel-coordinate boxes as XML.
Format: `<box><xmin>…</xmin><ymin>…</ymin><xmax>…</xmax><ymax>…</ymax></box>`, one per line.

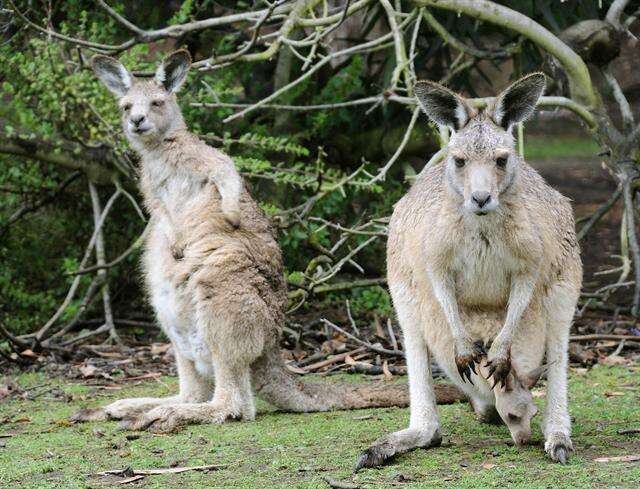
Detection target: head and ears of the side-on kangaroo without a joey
<box><xmin>91</xmin><ymin>49</ymin><xmax>191</xmax><ymax>148</ymax></box>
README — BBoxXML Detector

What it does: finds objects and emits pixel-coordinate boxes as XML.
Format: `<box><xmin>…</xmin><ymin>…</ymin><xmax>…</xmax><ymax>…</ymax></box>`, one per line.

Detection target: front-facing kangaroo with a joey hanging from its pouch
<box><xmin>356</xmin><ymin>73</ymin><xmax>582</xmax><ymax>470</ymax></box>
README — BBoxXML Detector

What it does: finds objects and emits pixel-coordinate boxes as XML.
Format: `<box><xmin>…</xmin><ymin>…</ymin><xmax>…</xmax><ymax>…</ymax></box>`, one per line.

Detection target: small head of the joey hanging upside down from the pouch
<box><xmin>493</xmin><ymin>364</ymin><xmax>547</xmax><ymax>445</ymax></box>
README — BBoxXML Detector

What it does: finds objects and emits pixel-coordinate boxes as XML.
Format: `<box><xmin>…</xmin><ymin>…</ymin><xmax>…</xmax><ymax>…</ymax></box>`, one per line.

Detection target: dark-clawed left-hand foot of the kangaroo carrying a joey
<box><xmin>353</xmin><ymin>426</ymin><xmax>442</xmax><ymax>472</ymax></box>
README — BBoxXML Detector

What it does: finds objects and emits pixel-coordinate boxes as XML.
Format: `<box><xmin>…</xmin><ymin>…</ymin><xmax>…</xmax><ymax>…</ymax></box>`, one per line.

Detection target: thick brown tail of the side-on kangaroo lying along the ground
<box><xmin>252</xmin><ymin>346</ymin><xmax>466</xmax><ymax>412</ymax></box>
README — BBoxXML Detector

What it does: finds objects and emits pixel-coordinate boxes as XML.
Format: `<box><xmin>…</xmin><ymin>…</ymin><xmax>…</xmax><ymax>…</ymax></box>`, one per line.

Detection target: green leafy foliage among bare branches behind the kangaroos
<box><xmin>0</xmin><ymin>0</ymin><xmax>632</xmax><ymax>333</ymax></box>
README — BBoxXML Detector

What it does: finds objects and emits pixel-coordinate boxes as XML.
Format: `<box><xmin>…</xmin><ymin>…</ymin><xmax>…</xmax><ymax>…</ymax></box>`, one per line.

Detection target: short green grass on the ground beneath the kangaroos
<box><xmin>0</xmin><ymin>367</ymin><xmax>640</xmax><ymax>488</ymax></box>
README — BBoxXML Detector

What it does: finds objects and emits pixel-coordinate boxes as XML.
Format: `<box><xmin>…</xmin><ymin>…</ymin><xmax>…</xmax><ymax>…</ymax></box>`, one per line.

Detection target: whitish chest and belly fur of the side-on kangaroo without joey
<box><xmin>142</xmin><ymin>152</ymin><xmax>213</xmax><ymax>376</ymax></box>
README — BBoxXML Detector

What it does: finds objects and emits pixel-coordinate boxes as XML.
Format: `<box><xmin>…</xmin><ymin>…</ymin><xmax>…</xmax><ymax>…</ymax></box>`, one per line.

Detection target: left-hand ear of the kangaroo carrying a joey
<box><xmin>413</xmin><ymin>81</ymin><xmax>470</xmax><ymax>131</ymax></box>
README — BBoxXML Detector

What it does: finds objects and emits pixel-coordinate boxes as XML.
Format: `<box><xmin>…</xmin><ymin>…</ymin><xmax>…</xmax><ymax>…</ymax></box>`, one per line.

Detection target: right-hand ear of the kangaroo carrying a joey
<box><xmin>493</xmin><ymin>73</ymin><xmax>546</xmax><ymax>130</ymax></box>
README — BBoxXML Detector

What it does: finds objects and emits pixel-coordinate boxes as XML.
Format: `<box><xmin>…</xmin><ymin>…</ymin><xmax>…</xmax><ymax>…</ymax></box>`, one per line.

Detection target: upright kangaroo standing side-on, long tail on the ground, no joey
<box><xmin>73</xmin><ymin>50</ymin><xmax>462</xmax><ymax>431</ymax></box>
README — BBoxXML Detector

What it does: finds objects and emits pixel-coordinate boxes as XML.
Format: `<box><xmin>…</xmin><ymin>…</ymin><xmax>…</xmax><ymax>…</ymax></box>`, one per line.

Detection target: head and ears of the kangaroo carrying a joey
<box><xmin>414</xmin><ymin>73</ymin><xmax>545</xmax><ymax>216</ymax></box>
